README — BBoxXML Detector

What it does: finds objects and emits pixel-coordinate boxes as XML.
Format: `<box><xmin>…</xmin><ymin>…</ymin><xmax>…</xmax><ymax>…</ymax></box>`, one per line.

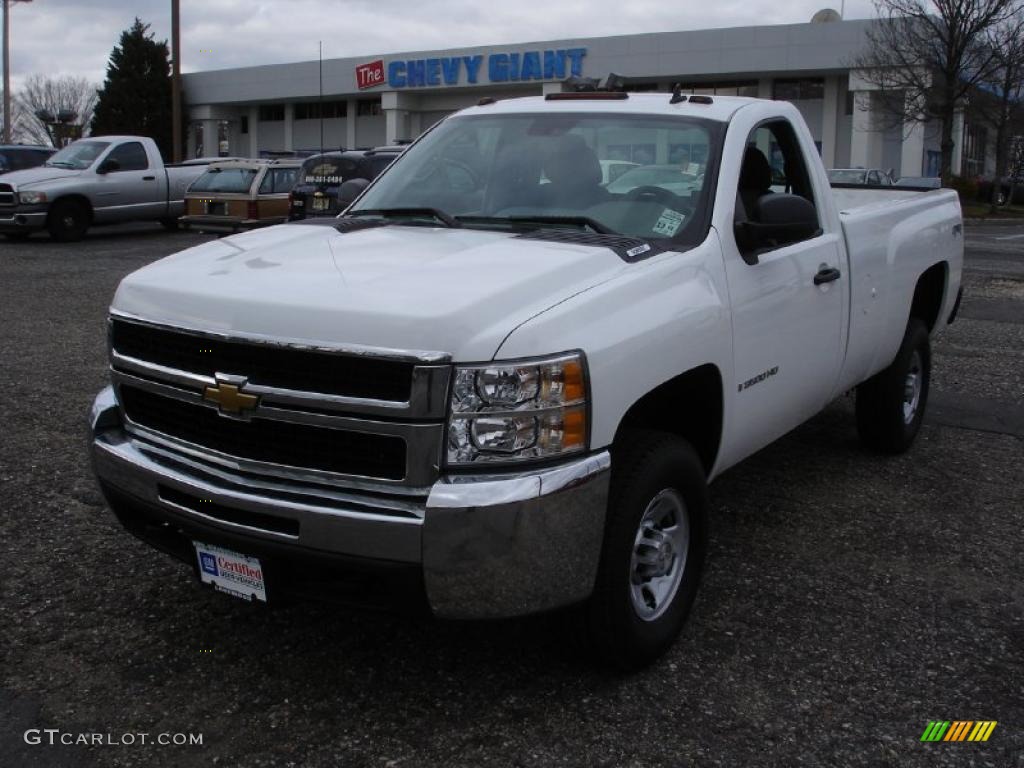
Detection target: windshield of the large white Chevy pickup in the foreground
<box><xmin>348</xmin><ymin>113</ymin><xmax>721</xmax><ymax>243</ymax></box>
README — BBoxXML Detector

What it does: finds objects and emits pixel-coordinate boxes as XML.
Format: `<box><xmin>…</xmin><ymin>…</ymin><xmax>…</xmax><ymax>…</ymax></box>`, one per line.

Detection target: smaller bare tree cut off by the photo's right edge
<box><xmin>971</xmin><ymin>16</ymin><xmax>1024</xmax><ymax>208</ymax></box>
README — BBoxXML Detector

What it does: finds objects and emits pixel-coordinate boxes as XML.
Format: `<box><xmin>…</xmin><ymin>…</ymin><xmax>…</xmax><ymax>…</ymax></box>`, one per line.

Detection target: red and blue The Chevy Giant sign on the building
<box><xmin>355</xmin><ymin>48</ymin><xmax>587</xmax><ymax>89</ymax></box>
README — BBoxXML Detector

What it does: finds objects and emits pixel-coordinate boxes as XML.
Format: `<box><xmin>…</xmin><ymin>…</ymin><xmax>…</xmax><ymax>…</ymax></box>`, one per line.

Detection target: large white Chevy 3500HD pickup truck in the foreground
<box><xmin>91</xmin><ymin>91</ymin><xmax>963</xmax><ymax>668</ymax></box>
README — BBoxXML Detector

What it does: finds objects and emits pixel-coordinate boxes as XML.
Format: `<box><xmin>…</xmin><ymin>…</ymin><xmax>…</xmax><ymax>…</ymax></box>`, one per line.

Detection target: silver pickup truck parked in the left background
<box><xmin>0</xmin><ymin>136</ymin><xmax>206</xmax><ymax>242</ymax></box>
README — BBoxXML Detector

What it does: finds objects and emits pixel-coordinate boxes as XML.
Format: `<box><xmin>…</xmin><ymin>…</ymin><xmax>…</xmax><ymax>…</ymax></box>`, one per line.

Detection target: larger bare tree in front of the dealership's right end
<box><xmin>851</xmin><ymin>0</ymin><xmax>1021</xmax><ymax>180</ymax></box>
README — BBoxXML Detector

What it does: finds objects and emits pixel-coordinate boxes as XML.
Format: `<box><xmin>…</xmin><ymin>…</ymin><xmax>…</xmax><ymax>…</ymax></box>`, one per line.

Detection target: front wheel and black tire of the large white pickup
<box><xmin>587</xmin><ymin>430</ymin><xmax>708</xmax><ymax>672</ymax></box>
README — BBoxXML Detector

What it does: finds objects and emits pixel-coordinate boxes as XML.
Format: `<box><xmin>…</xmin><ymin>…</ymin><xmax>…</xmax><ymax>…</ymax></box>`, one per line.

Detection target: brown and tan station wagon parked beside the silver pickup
<box><xmin>178</xmin><ymin>160</ymin><xmax>301</xmax><ymax>231</ymax></box>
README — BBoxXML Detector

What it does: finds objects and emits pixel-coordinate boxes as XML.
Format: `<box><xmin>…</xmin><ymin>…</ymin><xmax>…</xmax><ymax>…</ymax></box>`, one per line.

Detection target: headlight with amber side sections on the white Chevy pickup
<box><xmin>447</xmin><ymin>352</ymin><xmax>588</xmax><ymax>466</ymax></box>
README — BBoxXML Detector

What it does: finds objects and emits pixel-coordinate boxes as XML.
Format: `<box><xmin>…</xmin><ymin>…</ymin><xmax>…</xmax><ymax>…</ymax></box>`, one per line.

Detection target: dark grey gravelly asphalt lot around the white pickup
<box><xmin>0</xmin><ymin>219</ymin><xmax>1024</xmax><ymax>768</ymax></box>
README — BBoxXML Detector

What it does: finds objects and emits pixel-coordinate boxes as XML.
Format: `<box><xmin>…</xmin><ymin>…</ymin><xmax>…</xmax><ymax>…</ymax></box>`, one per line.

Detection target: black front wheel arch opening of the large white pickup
<box><xmin>612</xmin><ymin>362</ymin><xmax>725</xmax><ymax>475</ymax></box>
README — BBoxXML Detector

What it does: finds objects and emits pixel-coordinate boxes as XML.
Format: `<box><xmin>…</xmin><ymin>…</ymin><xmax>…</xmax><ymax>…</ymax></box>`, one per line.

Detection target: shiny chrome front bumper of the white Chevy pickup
<box><xmin>90</xmin><ymin>388</ymin><xmax>610</xmax><ymax>618</ymax></box>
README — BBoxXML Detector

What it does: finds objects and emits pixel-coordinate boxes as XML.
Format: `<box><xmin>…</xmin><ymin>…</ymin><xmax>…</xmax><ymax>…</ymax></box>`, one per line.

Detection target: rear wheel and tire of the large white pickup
<box><xmin>856</xmin><ymin>317</ymin><xmax>932</xmax><ymax>454</ymax></box>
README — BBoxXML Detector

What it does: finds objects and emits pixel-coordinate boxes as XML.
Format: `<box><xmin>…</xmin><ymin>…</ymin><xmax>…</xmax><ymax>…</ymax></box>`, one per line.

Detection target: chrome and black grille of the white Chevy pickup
<box><xmin>110</xmin><ymin>315</ymin><xmax>450</xmax><ymax>495</ymax></box>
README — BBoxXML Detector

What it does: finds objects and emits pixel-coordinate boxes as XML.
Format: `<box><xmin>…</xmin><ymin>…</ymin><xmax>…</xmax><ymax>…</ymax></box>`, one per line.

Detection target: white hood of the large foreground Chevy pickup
<box><xmin>112</xmin><ymin>224</ymin><xmax>629</xmax><ymax>361</ymax></box>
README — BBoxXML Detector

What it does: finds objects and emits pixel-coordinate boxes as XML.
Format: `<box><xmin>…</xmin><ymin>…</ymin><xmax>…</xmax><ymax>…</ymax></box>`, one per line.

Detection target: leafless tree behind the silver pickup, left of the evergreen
<box><xmin>14</xmin><ymin>75</ymin><xmax>96</xmax><ymax>146</ymax></box>
